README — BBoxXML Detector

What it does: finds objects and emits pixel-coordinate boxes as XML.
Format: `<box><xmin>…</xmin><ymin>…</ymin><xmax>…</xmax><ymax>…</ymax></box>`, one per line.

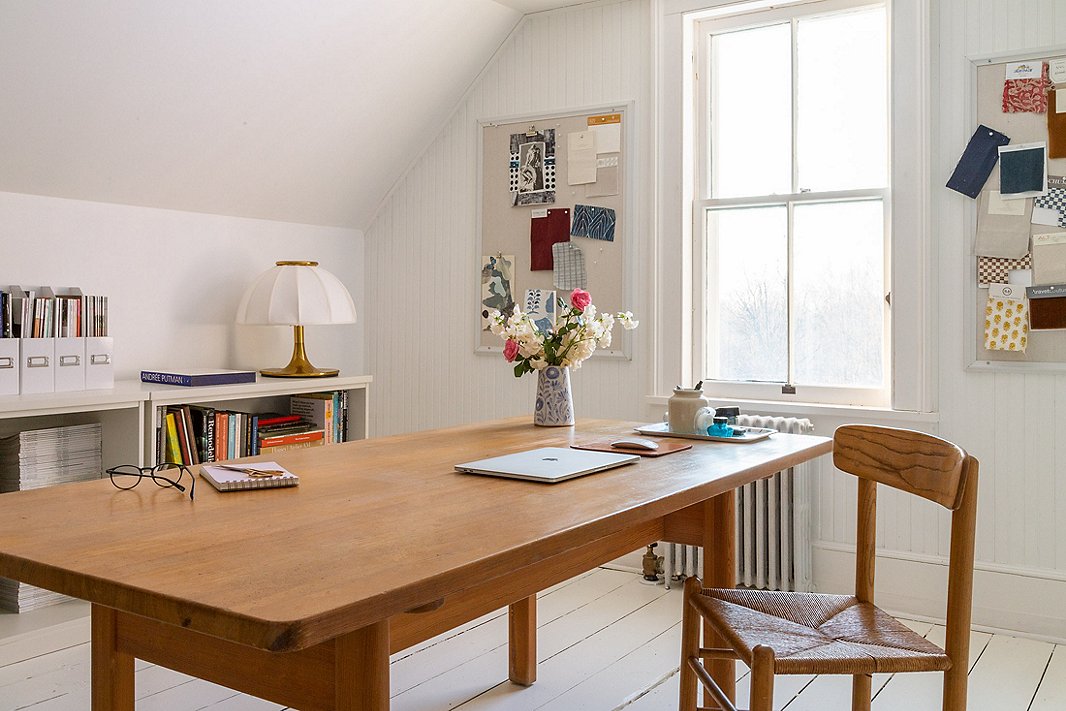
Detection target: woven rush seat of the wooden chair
<box><xmin>692</xmin><ymin>588</ymin><xmax>951</xmax><ymax>674</ymax></box>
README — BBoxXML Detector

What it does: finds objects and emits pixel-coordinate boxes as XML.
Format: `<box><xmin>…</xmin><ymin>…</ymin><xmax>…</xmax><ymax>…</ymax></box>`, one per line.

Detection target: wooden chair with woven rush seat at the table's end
<box><xmin>679</xmin><ymin>424</ymin><xmax>978</xmax><ymax>711</ymax></box>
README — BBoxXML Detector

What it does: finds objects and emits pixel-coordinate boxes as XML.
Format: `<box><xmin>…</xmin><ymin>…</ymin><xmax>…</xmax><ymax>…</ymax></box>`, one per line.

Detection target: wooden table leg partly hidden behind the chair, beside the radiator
<box><xmin>704</xmin><ymin>490</ymin><xmax>737</xmax><ymax>708</ymax></box>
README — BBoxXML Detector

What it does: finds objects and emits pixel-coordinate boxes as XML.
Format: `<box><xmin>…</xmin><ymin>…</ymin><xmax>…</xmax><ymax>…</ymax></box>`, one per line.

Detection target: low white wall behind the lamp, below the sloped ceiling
<box><xmin>0</xmin><ymin>188</ymin><xmax>366</xmax><ymax>378</ymax></box>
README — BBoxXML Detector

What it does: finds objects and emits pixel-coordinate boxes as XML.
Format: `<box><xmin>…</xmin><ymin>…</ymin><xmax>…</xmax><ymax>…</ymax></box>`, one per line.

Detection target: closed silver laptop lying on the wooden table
<box><xmin>455</xmin><ymin>447</ymin><xmax>641</xmax><ymax>484</ymax></box>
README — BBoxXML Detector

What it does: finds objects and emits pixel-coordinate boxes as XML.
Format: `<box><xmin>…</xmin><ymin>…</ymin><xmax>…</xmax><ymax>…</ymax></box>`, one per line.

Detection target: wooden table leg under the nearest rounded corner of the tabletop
<box><xmin>334</xmin><ymin>619</ymin><xmax>389</xmax><ymax>711</ymax></box>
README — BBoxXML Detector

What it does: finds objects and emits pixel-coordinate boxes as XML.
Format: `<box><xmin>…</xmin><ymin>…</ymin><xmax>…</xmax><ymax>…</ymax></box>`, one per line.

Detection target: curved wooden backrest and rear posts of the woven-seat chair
<box><xmin>833</xmin><ymin>424</ymin><xmax>978</xmax><ymax>684</ymax></box>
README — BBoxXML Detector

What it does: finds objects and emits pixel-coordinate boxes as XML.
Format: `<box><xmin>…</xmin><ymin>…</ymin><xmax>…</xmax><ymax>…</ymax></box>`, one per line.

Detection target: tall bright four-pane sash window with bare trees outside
<box><xmin>693</xmin><ymin>0</ymin><xmax>890</xmax><ymax>405</ymax></box>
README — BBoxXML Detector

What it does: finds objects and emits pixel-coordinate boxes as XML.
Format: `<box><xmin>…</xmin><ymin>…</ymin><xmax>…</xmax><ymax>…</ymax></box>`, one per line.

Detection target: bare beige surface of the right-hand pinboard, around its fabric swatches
<box><xmin>966</xmin><ymin>47</ymin><xmax>1066</xmax><ymax>372</ymax></box>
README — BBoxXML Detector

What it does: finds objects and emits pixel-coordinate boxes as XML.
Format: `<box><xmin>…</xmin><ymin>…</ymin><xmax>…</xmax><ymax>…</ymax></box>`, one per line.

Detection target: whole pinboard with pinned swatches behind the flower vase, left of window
<box><xmin>474</xmin><ymin>102</ymin><xmax>640</xmax><ymax>358</ymax></box>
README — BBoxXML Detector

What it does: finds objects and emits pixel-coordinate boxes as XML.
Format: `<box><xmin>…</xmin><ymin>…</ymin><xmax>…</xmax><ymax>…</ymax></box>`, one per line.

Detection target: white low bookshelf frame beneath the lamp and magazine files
<box><xmin>0</xmin><ymin>375</ymin><xmax>373</xmax><ymax>666</ymax></box>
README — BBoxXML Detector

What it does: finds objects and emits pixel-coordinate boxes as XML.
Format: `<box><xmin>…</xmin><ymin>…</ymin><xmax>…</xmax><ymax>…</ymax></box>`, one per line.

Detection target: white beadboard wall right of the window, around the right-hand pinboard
<box><xmin>815</xmin><ymin>0</ymin><xmax>1066</xmax><ymax>639</ymax></box>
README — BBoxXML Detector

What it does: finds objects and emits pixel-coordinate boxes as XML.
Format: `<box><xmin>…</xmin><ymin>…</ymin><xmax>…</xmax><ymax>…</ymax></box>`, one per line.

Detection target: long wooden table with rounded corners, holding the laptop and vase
<box><xmin>0</xmin><ymin>418</ymin><xmax>831</xmax><ymax>711</ymax></box>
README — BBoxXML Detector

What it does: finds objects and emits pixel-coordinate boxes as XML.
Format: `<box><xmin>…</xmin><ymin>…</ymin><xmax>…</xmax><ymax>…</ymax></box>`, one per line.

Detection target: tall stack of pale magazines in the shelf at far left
<box><xmin>0</xmin><ymin>423</ymin><xmax>103</xmax><ymax>612</ymax></box>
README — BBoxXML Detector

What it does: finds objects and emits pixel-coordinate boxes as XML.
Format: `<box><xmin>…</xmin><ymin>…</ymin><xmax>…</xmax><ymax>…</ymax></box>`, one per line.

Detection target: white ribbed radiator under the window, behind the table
<box><xmin>665</xmin><ymin>415</ymin><xmax>814</xmax><ymax>591</ymax></box>
